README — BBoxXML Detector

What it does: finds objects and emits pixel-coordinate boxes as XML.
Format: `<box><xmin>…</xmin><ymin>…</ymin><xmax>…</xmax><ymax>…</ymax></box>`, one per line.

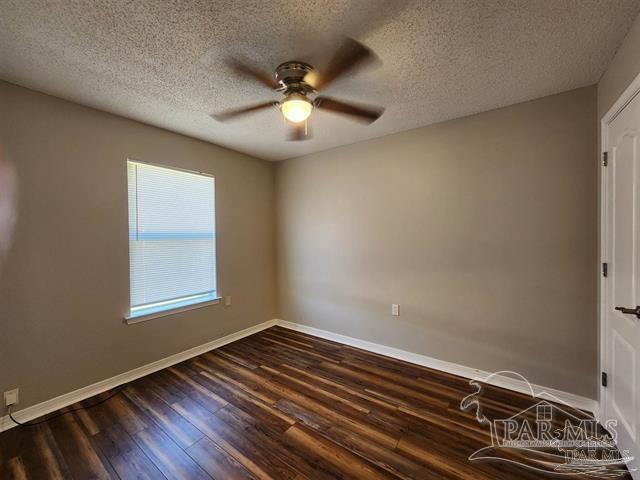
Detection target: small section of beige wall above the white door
<box><xmin>598</xmin><ymin>12</ymin><xmax>640</xmax><ymax>119</ymax></box>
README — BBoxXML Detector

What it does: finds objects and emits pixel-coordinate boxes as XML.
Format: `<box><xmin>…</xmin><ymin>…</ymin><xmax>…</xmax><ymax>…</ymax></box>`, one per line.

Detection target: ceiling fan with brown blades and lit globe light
<box><xmin>212</xmin><ymin>38</ymin><xmax>384</xmax><ymax>140</ymax></box>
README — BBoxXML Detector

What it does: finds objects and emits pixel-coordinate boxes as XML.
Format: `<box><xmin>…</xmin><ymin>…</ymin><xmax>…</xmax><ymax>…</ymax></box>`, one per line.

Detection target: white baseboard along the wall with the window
<box><xmin>0</xmin><ymin>320</ymin><xmax>277</xmax><ymax>432</ymax></box>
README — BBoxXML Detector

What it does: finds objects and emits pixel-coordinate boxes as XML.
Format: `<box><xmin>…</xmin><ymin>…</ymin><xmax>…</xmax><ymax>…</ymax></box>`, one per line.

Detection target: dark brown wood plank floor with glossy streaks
<box><xmin>0</xmin><ymin>327</ymin><xmax>632</xmax><ymax>480</ymax></box>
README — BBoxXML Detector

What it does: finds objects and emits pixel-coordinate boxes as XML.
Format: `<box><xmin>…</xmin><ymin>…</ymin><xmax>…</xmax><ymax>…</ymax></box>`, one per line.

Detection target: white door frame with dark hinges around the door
<box><xmin>597</xmin><ymin>74</ymin><xmax>640</xmax><ymax>420</ymax></box>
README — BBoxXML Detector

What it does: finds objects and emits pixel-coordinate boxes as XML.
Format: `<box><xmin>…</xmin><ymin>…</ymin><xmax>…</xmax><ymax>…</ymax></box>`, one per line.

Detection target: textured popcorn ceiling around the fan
<box><xmin>0</xmin><ymin>0</ymin><xmax>640</xmax><ymax>160</ymax></box>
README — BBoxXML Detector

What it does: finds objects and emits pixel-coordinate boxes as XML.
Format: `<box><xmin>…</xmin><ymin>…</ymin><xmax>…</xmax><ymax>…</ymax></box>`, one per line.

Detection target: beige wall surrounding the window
<box><xmin>0</xmin><ymin>82</ymin><xmax>275</xmax><ymax>413</ymax></box>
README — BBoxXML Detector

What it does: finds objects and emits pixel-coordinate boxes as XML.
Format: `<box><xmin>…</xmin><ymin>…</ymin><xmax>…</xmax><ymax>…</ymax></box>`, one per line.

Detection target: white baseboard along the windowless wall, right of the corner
<box><xmin>277</xmin><ymin>320</ymin><xmax>598</xmax><ymax>417</ymax></box>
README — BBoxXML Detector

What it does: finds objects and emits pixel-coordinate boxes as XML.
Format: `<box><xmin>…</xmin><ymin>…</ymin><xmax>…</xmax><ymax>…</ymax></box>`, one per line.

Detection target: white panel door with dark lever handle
<box><xmin>602</xmin><ymin>88</ymin><xmax>640</xmax><ymax>480</ymax></box>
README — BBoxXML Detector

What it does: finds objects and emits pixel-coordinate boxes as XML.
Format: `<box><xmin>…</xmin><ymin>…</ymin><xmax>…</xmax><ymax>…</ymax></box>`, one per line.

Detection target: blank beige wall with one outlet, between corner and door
<box><xmin>276</xmin><ymin>87</ymin><xmax>598</xmax><ymax>398</ymax></box>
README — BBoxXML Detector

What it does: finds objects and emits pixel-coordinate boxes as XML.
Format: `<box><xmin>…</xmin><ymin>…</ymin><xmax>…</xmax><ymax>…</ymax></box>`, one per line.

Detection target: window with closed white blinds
<box><xmin>127</xmin><ymin>161</ymin><xmax>217</xmax><ymax>319</ymax></box>
